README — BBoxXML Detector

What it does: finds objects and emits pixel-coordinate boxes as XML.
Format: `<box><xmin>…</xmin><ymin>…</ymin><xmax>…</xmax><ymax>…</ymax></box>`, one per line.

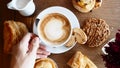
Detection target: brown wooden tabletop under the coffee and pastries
<box><xmin>0</xmin><ymin>0</ymin><xmax>120</xmax><ymax>68</ymax></box>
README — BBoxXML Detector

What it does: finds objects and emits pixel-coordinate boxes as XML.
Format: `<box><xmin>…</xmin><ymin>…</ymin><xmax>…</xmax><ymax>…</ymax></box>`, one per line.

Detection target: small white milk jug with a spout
<box><xmin>7</xmin><ymin>0</ymin><xmax>35</xmax><ymax>16</ymax></box>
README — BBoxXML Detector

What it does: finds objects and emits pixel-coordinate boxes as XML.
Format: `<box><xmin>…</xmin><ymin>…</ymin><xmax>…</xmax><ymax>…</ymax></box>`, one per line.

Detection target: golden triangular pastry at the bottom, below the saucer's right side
<box><xmin>67</xmin><ymin>51</ymin><xmax>97</xmax><ymax>68</ymax></box>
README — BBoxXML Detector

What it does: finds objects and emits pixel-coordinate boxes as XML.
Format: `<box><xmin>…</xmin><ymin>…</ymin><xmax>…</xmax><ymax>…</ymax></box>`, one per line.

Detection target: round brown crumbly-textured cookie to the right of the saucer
<box><xmin>83</xmin><ymin>18</ymin><xmax>110</xmax><ymax>47</ymax></box>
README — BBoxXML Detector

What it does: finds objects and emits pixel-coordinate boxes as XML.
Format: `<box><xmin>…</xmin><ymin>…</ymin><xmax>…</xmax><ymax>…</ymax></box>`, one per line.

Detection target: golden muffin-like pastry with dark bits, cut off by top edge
<box><xmin>72</xmin><ymin>0</ymin><xmax>102</xmax><ymax>13</ymax></box>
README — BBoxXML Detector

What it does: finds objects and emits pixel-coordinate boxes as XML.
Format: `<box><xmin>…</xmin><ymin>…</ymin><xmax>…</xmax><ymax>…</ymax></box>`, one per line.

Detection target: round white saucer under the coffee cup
<box><xmin>33</xmin><ymin>6</ymin><xmax>80</xmax><ymax>54</ymax></box>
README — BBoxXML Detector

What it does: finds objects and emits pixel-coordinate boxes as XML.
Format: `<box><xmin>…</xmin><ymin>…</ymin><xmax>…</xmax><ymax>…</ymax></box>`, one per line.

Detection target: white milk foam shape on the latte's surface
<box><xmin>44</xmin><ymin>18</ymin><xmax>65</xmax><ymax>41</ymax></box>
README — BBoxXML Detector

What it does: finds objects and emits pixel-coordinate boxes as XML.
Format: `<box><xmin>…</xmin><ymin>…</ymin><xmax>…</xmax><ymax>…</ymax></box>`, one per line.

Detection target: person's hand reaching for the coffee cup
<box><xmin>11</xmin><ymin>33</ymin><xmax>50</xmax><ymax>68</ymax></box>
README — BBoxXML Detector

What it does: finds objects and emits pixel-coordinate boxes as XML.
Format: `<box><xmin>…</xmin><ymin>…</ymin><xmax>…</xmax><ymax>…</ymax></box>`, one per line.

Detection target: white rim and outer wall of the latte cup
<box><xmin>37</xmin><ymin>15</ymin><xmax>72</xmax><ymax>47</ymax></box>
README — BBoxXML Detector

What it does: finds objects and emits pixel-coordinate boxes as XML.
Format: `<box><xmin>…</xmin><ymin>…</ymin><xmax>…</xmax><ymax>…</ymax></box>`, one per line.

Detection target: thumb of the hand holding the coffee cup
<box><xmin>30</xmin><ymin>37</ymin><xmax>39</xmax><ymax>54</ymax></box>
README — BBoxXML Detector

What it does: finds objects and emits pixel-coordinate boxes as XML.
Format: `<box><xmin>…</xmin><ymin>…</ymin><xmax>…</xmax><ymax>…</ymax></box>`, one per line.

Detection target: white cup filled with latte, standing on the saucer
<box><xmin>37</xmin><ymin>13</ymin><xmax>72</xmax><ymax>47</ymax></box>
